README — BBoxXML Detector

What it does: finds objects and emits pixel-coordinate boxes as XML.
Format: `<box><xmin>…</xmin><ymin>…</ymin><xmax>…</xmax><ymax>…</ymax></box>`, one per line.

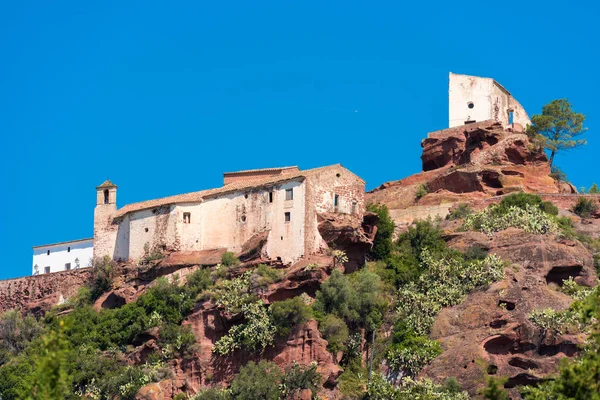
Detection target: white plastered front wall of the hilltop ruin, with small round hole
<box><xmin>448</xmin><ymin>73</ymin><xmax>494</xmax><ymax>128</ymax></box>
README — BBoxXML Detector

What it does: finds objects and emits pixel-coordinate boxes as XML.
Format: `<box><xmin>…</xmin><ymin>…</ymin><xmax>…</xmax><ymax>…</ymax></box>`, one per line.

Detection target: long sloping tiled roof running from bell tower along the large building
<box><xmin>115</xmin><ymin>164</ymin><xmax>354</xmax><ymax>218</ymax></box>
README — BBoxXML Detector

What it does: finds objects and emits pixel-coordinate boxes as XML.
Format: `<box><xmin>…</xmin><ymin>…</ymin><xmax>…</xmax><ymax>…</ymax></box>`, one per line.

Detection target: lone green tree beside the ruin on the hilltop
<box><xmin>527</xmin><ymin>99</ymin><xmax>587</xmax><ymax>165</ymax></box>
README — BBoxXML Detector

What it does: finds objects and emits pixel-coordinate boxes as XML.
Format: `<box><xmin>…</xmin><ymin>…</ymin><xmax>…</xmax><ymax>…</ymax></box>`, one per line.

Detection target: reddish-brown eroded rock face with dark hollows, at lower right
<box><xmin>423</xmin><ymin>229</ymin><xmax>596</xmax><ymax>398</ymax></box>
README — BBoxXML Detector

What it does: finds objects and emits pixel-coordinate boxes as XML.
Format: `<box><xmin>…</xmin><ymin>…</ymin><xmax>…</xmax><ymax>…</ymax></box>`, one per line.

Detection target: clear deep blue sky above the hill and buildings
<box><xmin>0</xmin><ymin>0</ymin><xmax>600</xmax><ymax>278</ymax></box>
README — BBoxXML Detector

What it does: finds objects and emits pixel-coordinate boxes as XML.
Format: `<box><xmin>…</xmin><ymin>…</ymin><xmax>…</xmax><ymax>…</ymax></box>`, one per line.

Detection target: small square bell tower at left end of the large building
<box><xmin>94</xmin><ymin>180</ymin><xmax>117</xmax><ymax>259</ymax></box>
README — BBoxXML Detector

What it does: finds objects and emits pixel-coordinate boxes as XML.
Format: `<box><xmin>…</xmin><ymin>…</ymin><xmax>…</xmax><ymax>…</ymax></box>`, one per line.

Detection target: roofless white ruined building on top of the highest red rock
<box><xmin>448</xmin><ymin>72</ymin><xmax>531</xmax><ymax>132</ymax></box>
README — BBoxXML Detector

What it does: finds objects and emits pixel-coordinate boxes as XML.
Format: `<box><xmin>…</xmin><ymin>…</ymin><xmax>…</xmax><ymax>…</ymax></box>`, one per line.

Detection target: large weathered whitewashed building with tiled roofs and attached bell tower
<box><xmin>94</xmin><ymin>164</ymin><xmax>365</xmax><ymax>263</ymax></box>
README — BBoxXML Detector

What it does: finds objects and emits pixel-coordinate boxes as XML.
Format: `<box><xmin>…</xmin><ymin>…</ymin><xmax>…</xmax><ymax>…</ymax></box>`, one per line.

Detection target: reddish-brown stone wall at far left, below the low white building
<box><xmin>0</xmin><ymin>268</ymin><xmax>92</xmax><ymax>313</ymax></box>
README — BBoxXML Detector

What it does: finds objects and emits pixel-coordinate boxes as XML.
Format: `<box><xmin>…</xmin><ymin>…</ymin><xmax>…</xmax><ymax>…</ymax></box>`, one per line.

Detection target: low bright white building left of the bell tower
<box><xmin>32</xmin><ymin>239</ymin><xmax>94</xmax><ymax>275</ymax></box>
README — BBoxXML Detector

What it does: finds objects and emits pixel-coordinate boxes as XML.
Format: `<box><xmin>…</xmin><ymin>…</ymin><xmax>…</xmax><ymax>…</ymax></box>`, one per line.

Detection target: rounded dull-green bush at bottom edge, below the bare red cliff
<box><xmin>230</xmin><ymin>360</ymin><xmax>282</xmax><ymax>400</ymax></box>
